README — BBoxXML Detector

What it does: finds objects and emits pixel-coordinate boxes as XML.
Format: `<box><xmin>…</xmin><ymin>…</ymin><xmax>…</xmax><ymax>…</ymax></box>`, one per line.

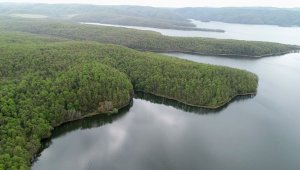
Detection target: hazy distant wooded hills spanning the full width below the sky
<box><xmin>0</xmin><ymin>3</ymin><xmax>300</xmax><ymax>27</ymax></box>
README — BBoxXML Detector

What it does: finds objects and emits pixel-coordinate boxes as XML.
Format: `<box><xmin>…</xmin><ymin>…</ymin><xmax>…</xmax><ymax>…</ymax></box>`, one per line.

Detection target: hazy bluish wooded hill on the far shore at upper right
<box><xmin>176</xmin><ymin>7</ymin><xmax>300</xmax><ymax>27</ymax></box>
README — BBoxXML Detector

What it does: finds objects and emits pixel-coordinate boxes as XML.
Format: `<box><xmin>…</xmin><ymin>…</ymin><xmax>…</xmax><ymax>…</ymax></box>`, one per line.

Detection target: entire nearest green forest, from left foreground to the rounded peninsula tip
<box><xmin>0</xmin><ymin>31</ymin><xmax>258</xmax><ymax>170</ymax></box>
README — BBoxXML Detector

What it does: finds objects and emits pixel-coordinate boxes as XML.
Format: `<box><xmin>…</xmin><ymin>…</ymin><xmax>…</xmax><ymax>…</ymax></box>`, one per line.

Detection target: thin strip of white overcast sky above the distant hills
<box><xmin>0</xmin><ymin>0</ymin><xmax>300</xmax><ymax>8</ymax></box>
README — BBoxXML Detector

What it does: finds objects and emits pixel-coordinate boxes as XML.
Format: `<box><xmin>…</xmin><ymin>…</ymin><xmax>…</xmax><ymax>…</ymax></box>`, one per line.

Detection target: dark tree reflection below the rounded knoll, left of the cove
<box><xmin>33</xmin><ymin>102</ymin><xmax>133</xmax><ymax>162</ymax></box>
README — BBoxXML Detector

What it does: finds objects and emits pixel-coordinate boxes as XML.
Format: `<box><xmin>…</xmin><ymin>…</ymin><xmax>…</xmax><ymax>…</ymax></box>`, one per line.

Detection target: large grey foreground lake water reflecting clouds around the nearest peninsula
<box><xmin>32</xmin><ymin>21</ymin><xmax>300</xmax><ymax>170</ymax></box>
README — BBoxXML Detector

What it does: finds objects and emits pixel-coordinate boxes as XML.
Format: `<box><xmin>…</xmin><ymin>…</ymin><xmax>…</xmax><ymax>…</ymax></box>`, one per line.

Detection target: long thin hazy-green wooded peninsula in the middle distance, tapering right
<box><xmin>0</xmin><ymin>18</ymin><xmax>299</xmax><ymax>57</ymax></box>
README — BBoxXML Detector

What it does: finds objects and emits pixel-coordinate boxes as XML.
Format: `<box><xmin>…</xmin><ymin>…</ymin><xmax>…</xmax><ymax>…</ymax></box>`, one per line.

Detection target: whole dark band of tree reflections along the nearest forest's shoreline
<box><xmin>33</xmin><ymin>92</ymin><xmax>254</xmax><ymax>162</ymax></box>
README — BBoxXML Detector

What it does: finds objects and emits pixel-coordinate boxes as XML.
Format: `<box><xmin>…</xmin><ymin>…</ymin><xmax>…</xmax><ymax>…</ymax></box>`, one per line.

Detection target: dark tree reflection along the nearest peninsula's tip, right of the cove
<box><xmin>135</xmin><ymin>92</ymin><xmax>255</xmax><ymax>114</ymax></box>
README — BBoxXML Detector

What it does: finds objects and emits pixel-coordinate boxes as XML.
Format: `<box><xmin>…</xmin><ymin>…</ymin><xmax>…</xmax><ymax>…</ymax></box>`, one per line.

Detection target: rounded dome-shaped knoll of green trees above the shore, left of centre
<box><xmin>57</xmin><ymin>63</ymin><xmax>132</xmax><ymax>114</ymax></box>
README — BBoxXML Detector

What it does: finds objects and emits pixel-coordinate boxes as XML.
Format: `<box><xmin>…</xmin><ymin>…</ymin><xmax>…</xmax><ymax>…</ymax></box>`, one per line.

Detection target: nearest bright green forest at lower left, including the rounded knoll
<box><xmin>0</xmin><ymin>63</ymin><xmax>133</xmax><ymax>170</ymax></box>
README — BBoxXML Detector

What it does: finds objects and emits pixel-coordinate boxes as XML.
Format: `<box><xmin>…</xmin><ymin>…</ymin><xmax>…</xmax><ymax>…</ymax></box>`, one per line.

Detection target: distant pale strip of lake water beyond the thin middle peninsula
<box><xmin>83</xmin><ymin>20</ymin><xmax>300</xmax><ymax>45</ymax></box>
